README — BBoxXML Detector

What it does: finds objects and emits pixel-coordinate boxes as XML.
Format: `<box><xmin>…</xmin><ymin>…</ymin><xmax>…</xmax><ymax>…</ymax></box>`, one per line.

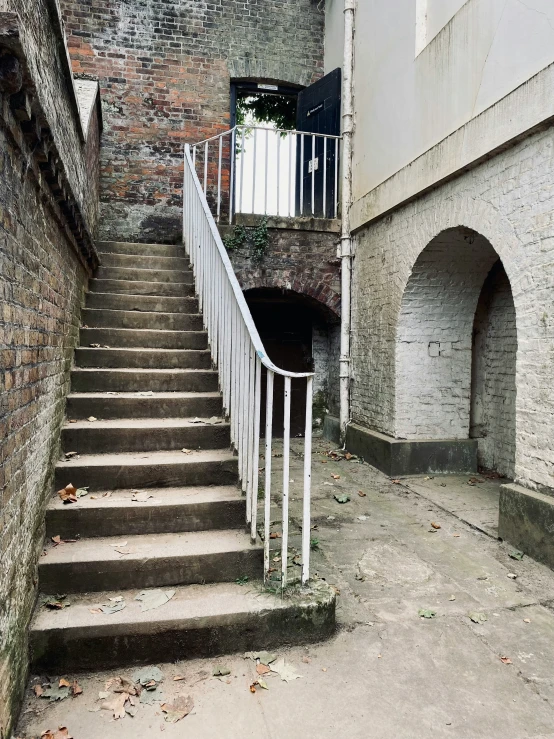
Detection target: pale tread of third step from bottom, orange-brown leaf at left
<box><xmin>47</xmin><ymin>485</ymin><xmax>237</xmax><ymax>511</ymax></box>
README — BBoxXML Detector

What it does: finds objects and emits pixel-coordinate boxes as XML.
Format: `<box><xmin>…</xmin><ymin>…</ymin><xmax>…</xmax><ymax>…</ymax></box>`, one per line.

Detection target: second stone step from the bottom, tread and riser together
<box><xmin>38</xmin><ymin>529</ymin><xmax>263</xmax><ymax>593</ymax></box>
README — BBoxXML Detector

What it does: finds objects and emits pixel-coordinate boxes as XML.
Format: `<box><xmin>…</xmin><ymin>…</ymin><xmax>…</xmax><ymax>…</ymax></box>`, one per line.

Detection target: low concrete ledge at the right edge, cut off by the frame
<box><xmin>498</xmin><ymin>484</ymin><xmax>554</xmax><ymax>569</ymax></box>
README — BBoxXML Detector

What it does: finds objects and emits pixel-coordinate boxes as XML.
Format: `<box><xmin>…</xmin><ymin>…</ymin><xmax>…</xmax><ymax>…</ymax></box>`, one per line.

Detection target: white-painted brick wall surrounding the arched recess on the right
<box><xmin>352</xmin><ymin>128</ymin><xmax>554</xmax><ymax>493</ymax></box>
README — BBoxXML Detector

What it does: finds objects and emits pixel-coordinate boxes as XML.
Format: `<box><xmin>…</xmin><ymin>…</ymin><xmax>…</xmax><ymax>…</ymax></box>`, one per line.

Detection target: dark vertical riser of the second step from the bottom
<box><xmin>39</xmin><ymin>544</ymin><xmax>263</xmax><ymax>593</ymax></box>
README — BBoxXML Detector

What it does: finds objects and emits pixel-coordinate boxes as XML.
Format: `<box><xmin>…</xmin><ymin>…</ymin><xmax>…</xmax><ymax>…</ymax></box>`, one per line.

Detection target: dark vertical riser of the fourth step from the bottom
<box><xmin>55</xmin><ymin>455</ymin><xmax>238</xmax><ymax>492</ymax></box>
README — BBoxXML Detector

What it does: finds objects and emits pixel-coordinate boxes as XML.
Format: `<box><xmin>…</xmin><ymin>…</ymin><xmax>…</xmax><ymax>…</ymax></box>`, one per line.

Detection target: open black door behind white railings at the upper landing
<box><xmin>296</xmin><ymin>69</ymin><xmax>341</xmax><ymax>218</ymax></box>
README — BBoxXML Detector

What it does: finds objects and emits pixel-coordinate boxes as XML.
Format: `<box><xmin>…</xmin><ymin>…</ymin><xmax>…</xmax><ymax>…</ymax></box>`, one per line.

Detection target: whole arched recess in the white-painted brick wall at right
<box><xmin>396</xmin><ymin>227</ymin><xmax>517</xmax><ymax>476</ymax></box>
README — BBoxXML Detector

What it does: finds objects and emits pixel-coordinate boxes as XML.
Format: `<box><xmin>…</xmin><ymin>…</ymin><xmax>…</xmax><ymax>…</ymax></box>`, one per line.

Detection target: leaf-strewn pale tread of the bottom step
<box><xmin>31</xmin><ymin>581</ymin><xmax>289</xmax><ymax>634</ymax></box>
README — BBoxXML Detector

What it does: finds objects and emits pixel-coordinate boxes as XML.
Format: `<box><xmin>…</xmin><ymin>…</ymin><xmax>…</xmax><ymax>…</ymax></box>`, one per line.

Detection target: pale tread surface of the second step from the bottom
<box><xmin>40</xmin><ymin>529</ymin><xmax>256</xmax><ymax>567</ymax></box>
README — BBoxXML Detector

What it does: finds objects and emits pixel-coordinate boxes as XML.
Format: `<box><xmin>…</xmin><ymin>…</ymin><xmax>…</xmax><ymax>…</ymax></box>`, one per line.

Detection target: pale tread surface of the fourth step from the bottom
<box><xmin>56</xmin><ymin>449</ymin><xmax>236</xmax><ymax>473</ymax></box>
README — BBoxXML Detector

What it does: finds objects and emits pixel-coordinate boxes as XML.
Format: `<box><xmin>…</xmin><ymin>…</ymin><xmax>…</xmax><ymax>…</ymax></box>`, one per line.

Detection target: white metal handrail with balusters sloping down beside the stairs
<box><xmin>183</xmin><ymin>144</ymin><xmax>313</xmax><ymax>587</ymax></box>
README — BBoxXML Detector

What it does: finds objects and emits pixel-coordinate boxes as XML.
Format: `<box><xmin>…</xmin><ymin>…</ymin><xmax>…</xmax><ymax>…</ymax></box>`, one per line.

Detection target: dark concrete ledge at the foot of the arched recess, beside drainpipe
<box><xmin>340</xmin><ymin>424</ymin><xmax>477</xmax><ymax>477</ymax></box>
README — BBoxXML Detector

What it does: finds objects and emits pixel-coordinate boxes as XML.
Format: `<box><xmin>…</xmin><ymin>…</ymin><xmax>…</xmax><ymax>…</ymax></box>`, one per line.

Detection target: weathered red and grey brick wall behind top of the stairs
<box><xmin>62</xmin><ymin>0</ymin><xmax>324</xmax><ymax>242</ymax></box>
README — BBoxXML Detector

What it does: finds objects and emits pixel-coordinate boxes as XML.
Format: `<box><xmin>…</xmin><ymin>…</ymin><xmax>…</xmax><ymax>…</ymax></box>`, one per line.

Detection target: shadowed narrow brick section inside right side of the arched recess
<box><xmin>470</xmin><ymin>262</ymin><xmax>517</xmax><ymax>477</ymax></box>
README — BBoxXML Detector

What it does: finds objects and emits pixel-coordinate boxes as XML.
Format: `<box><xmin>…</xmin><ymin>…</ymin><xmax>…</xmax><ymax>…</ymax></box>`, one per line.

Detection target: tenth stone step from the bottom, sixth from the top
<box><xmin>81</xmin><ymin>308</ymin><xmax>204</xmax><ymax>331</ymax></box>
